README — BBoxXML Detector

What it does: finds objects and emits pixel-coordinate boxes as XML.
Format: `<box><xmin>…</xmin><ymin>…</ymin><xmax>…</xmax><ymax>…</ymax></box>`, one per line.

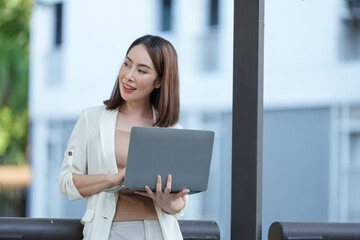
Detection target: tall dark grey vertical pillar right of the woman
<box><xmin>231</xmin><ymin>0</ymin><xmax>264</xmax><ymax>240</ymax></box>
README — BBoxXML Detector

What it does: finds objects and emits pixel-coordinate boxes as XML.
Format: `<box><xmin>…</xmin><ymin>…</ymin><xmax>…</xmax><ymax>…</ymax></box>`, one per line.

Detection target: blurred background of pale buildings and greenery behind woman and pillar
<box><xmin>0</xmin><ymin>0</ymin><xmax>360</xmax><ymax>239</ymax></box>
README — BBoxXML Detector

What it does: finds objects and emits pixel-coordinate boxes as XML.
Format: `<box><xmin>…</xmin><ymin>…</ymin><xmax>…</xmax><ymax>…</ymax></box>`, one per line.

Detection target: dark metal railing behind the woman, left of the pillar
<box><xmin>0</xmin><ymin>217</ymin><xmax>220</xmax><ymax>240</ymax></box>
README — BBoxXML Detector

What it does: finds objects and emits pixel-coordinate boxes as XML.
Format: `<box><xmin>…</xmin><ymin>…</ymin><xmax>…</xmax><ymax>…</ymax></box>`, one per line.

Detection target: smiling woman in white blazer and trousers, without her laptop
<box><xmin>57</xmin><ymin>35</ymin><xmax>189</xmax><ymax>240</ymax></box>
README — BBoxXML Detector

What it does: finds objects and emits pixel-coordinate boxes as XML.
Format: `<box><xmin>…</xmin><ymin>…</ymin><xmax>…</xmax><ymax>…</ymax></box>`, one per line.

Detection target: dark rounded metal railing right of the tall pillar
<box><xmin>268</xmin><ymin>222</ymin><xmax>360</xmax><ymax>240</ymax></box>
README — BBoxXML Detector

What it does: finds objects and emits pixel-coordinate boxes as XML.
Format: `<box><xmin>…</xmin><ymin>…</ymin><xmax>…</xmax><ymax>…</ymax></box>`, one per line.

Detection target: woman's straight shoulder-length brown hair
<box><xmin>104</xmin><ymin>35</ymin><xmax>180</xmax><ymax>127</ymax></box>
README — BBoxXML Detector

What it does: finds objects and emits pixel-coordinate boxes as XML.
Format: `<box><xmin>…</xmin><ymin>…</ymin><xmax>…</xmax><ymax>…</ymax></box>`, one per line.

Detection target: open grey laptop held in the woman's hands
<box><xmin>106</xmin><ymin>127</ymin><xmax>215</xmax><ymax>193</ymax></box>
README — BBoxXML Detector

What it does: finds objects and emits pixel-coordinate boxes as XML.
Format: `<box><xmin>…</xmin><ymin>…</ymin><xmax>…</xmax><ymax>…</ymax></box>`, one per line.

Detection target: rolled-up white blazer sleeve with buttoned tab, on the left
<box><xmin>57</xmin><ymin>110</ymin><xmax>88</xmax><ymax>201</ymax></box>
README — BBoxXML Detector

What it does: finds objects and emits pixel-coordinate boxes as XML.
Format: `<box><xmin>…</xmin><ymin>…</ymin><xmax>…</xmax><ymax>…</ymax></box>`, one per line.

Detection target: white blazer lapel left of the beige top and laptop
<box><xmin>100</xmin><ymin>110</ymin><xmax>118</xmax><ymax>174</ymax></box>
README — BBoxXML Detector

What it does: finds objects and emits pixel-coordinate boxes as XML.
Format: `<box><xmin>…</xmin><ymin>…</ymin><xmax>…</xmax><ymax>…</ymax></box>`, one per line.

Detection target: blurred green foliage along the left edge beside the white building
<box><xmin>0</xmin><ymin>0</ymin><xmax>32</xmax><ymax>164</ymax></box>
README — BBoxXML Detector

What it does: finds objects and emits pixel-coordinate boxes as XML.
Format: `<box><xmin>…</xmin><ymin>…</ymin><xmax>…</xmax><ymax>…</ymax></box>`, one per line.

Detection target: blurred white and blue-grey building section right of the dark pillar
<box><xmin>263</xmin><ymin>0</ymin><xmax>360</xmax><ymax>231</ymax></box>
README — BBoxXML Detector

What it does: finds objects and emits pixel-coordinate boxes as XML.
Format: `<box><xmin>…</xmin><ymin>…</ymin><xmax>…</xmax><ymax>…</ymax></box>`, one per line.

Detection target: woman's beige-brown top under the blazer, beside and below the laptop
<box><xmin>113</xmin><ymin>129</ymin><xmax>157</xmax><ymax>222</ymax></box>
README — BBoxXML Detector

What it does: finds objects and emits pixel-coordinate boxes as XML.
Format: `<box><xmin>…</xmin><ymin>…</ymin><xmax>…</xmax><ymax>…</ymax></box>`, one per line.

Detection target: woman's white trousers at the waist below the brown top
<box><xmin>109</xmin><ymin>220</ymin><xmax>164</xmax><ymax>240</ymax></box>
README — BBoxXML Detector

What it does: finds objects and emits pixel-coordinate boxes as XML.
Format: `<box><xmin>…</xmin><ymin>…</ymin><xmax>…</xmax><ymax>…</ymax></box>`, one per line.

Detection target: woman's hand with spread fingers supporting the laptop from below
<box><xmin>135</xmin><ymin>174</ymin><xmax>190</xmax><ymax>214</ymax></box>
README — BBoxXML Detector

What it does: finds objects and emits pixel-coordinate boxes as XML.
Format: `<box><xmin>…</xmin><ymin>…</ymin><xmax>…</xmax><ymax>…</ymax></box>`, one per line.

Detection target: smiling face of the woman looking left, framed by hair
<box><xmin>119</xmin><ymin>44</ymin><xmax>160</xmax><ymax>104</ymax></box>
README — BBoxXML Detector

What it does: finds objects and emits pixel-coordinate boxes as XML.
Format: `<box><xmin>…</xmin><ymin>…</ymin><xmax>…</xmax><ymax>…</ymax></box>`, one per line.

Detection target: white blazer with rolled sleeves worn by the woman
<box><xmin>57</xmin><ymin>106</ymin><xmax>187</xmax><ymax>240</ymax></box>
